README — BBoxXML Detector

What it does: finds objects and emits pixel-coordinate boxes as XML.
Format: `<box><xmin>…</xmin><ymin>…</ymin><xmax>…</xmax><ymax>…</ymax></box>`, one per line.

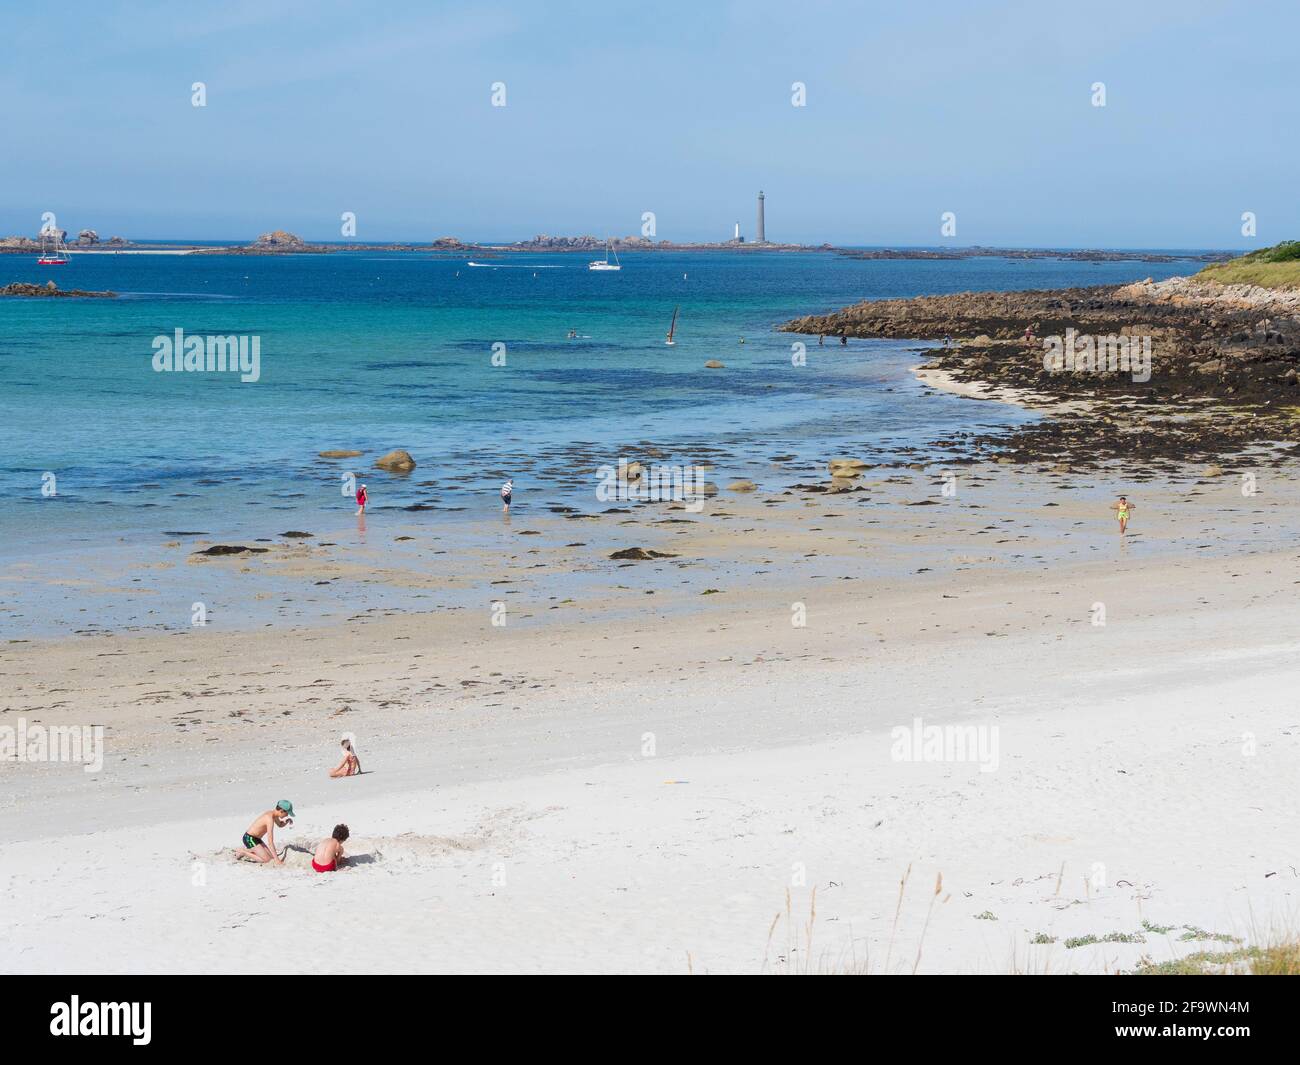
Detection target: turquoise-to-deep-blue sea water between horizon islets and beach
<box><xmin>0</xmin><ymin>252</ymin><xmax>1191</xmax><ymax>559</ymax></box>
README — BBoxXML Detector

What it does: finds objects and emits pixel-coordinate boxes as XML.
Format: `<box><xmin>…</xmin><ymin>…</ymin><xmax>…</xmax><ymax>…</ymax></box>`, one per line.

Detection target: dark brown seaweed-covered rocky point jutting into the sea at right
<box><xmin>780</xmin><ymin>277</ymin><xmax>1300</xmax><ymax>466</ymax></box>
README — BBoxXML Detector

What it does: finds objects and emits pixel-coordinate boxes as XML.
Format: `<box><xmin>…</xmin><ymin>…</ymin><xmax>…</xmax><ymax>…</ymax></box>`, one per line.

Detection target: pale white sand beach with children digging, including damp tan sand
<box><xmin>0</xmin><ymin>471</ymin><xmax>1300</xmax><ymax>973</ymax></box>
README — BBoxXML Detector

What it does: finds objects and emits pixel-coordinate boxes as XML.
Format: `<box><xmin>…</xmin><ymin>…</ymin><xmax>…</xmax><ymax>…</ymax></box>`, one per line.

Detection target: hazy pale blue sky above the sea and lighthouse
<box><xmin>0</xmin><ymin>0</ymin><xmax>1300</xmax><ymax>248</ymax></box>
